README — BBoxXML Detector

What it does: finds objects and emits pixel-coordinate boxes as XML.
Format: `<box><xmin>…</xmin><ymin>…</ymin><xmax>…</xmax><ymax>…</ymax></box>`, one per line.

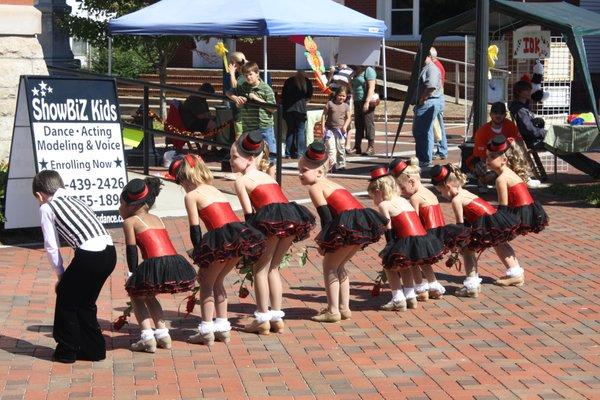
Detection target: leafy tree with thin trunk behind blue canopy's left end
<box><xmin>61</xmin><ymin>0</ymin><xmax>195</xmax><ymax>115</ymax></box>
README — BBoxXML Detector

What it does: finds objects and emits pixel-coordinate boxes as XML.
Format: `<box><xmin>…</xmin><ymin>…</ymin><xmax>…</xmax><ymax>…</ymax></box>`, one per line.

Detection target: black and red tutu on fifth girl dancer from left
<box><xmin>379</xmin><ymin>232</ymin><xmax>444</xmax><ymax>270</ymax></box>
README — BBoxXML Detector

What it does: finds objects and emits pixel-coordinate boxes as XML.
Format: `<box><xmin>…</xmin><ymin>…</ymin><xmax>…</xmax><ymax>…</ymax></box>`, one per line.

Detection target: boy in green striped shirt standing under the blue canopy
<box><xmin>226</xmin><ymin>62</ymin><xmax>277</xmax><ymax>163</ymax></box>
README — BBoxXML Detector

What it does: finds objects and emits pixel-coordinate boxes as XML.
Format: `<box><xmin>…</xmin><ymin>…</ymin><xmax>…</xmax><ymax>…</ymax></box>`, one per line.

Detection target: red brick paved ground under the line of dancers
<box><xmin>0</xmin><ymin>126</ymin><xmax>600</xmax><ymax>400</ymax></box>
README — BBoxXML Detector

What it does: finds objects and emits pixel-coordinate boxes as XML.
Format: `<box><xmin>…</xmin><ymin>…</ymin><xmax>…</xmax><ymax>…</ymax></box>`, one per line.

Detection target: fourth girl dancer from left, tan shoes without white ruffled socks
<box><xmin>298</xmin><ymin>142</ymin><xmax>387</xmax><ymax>322</ymax></box>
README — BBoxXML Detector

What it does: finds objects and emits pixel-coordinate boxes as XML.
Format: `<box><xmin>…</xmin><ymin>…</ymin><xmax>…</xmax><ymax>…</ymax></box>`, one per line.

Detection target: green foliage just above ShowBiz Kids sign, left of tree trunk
<box><xmin>92</xmin><ymin>48</ymin><xmax>154</xmax><ymax>78</ymax></box>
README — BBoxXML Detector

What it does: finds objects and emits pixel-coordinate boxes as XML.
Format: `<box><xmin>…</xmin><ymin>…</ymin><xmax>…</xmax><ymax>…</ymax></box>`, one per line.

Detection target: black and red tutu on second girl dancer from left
<box><xmin>191</xmin><ymin>222</ymin><xmax>265</xmax><ymax>268</ymax></box>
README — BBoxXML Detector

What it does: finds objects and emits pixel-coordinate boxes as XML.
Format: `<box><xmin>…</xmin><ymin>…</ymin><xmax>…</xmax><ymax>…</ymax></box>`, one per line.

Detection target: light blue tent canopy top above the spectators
<box><xmin>108</xmin><ymin>0</ymin><xmax>386</xmax><ymax>38</ymax></box>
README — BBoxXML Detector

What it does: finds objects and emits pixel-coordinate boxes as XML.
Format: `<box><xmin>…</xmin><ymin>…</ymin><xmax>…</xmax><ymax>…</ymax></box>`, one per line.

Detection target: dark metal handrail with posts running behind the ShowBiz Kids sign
<box><xmin>48</xmin><ymin>66</ymin><xmax>283</xmax><ymax>184</ymax></box>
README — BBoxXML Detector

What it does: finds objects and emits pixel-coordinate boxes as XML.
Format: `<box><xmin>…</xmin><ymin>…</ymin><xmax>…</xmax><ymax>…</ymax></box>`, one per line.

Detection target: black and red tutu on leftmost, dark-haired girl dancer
<box><xmin>125</xmin><ymin>254</ymin><xmax>196</xmax><ymax>296</ymax></box>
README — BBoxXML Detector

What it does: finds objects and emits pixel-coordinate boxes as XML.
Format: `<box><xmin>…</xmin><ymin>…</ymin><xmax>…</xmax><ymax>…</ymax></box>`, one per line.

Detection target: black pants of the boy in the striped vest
<box><xmin>52</xmin><ymin>246</ymin><xmax>117</xmax><ymax>361</ymax></box>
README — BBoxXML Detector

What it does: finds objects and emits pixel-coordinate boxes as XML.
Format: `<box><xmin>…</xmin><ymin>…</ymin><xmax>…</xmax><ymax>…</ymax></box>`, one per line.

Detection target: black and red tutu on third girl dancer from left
<box><xmin>246</xmin><ymin>201</ymin><xmax>315</xmax><ymax>242</ymax></box>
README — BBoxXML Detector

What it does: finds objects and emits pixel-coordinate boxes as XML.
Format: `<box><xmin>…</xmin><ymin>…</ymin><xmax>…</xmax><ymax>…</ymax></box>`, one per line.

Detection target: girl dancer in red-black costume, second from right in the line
<box><xmin>431</xmin><ymin>164</ymin><xmax>522</xmax><ymax>297</ymax></box>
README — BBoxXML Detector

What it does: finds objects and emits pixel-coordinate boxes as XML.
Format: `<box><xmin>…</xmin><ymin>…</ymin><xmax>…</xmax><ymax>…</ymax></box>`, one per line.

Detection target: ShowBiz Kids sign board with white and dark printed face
<box><xmin>26</xmin><ymin>78</ymin><xmax>127</xmax><ymax>223</ymax></box>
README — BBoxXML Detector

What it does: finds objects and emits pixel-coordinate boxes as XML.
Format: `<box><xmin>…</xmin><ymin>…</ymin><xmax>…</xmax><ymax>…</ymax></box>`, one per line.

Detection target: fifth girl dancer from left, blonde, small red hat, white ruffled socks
<box><xmin>368</xmin><ymin>167</ymin><xmax>444</xmax><ymax>311</ymax></box>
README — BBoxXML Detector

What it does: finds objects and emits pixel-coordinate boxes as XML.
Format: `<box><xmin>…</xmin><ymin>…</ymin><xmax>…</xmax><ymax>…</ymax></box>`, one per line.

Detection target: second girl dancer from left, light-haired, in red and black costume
<box><xmin>169</xmin><ymin>154</ymin><xmax>265</xmax><ymax>346</ymax></box>
